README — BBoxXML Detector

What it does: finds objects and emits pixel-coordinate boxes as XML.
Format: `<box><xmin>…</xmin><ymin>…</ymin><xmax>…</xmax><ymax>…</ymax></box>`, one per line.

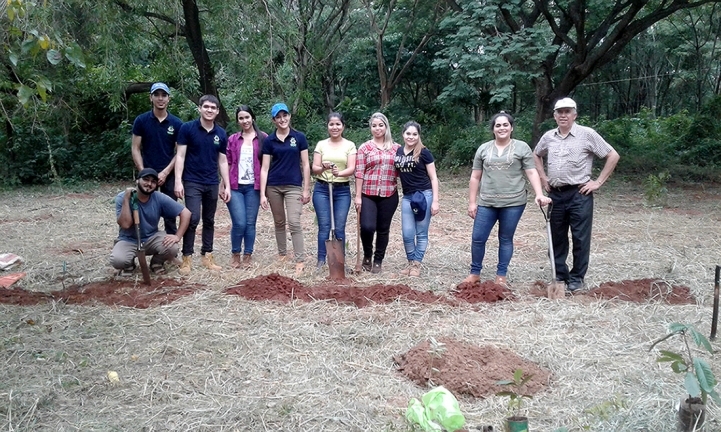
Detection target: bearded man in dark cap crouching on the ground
<box><xmin>110</xmin><ymin>168</ymin><xmax>190</xmax><ymax>274</ymax></box>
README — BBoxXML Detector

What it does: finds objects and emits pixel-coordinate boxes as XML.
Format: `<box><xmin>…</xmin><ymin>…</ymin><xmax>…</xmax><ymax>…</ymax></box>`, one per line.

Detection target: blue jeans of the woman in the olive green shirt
<box><xmin>471</xmin><ymin>204</ymin><xmax>526</xmax><ymax>276</ymax></box>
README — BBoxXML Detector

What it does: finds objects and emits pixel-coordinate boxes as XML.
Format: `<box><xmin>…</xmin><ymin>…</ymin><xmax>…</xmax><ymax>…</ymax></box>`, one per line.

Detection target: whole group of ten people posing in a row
<box><xmin>111</xmin><ymin>83</ymin><xmax>618</xmax><ymax>290</ymax></box>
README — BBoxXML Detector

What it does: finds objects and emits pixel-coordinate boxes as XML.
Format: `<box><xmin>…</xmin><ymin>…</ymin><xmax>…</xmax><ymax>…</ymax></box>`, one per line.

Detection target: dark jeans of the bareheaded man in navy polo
<box><xmin>183</xmin><ymin>182</ymin><xmax>218</xmax><ymax>256</ymax></box>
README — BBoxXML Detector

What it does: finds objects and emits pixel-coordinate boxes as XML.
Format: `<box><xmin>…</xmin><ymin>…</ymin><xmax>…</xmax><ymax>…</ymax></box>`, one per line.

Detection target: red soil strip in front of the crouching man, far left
<box><xmin>0</xmin><ymin>279</ymin><xmax>201</xmax><ymax>309</ymax></box>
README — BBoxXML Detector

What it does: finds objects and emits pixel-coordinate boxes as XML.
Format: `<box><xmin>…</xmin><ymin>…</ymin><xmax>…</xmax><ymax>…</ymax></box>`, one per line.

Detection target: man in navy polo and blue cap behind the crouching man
<box><xmin>132</xmin><ymin>82</ymin><xmax>183</xmax><ymax>234</ymax></box>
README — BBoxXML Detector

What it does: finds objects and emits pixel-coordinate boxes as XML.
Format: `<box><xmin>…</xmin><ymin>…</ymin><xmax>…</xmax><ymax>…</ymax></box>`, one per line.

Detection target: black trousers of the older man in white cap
<box><xmin>549</xmin><ymin>188</ymin><xmax>593</xmax><ymax>282</ymax></box>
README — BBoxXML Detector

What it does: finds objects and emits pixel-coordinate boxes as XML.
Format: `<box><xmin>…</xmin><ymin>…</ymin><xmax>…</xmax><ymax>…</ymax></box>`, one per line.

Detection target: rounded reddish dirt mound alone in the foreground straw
<box><xmin>394</xmin><ymin>338</ymin><xmax>551</xmax><ymax>398</ymax></box>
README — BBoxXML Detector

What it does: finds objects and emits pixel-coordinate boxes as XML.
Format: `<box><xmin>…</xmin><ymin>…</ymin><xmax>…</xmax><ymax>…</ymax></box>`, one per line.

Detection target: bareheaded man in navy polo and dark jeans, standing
<box><xmin>175</xmin><ymin>95</ymin><xmax>230</xmax><ymax>275</ymax></box>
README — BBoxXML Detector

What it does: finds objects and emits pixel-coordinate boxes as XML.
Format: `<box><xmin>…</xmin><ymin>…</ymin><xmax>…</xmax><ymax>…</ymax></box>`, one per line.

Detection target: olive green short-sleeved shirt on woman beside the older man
<box><xmin>473</xmin><ymin>139</ymin><xmax>536</xmax><ymax>207</ymax></box>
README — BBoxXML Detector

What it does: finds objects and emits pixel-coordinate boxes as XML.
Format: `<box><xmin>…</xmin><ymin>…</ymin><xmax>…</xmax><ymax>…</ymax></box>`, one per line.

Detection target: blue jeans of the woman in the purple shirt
<box><xmin>227</xmin><ymin>184</ymin><xmax>260</xmax><ymax>254</ymax></box>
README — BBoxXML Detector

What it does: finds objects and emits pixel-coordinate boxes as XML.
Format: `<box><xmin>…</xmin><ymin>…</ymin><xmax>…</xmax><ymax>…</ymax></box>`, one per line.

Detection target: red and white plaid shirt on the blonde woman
<box><xmin>355</xmin><ymin>140</ymin><xmax>401</xmax><ymax>198</ymax></box>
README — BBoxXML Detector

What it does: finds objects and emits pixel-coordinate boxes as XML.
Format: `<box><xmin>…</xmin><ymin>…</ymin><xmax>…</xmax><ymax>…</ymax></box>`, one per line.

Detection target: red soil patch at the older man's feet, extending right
<box><xmin>531</xmin><ymin>279</ymin><xmax>696</xmax><ymax>305</ymax></box>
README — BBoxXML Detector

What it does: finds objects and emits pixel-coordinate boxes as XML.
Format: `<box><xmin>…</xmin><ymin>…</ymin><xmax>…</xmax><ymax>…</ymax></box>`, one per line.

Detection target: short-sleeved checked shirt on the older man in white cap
<box><xmin>534</xmin><ymin>123</ymin><xmax>613</xmax><ymax>187</ymax></box>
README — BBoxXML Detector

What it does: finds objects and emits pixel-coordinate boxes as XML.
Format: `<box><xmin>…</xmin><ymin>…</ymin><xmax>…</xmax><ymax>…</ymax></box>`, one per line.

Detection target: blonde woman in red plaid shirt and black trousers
<box><xmin>355</xmin><ymin>113</ymin><xmax>400</xmax><ymax>273</ymax></box>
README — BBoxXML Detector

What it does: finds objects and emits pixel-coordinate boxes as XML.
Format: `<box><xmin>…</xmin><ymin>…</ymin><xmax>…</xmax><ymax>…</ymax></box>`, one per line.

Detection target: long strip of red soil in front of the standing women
<box><xmin>225</xmin><ymin>273</ymin><xmax>513</xmax><ymax>307</ymax></box>
